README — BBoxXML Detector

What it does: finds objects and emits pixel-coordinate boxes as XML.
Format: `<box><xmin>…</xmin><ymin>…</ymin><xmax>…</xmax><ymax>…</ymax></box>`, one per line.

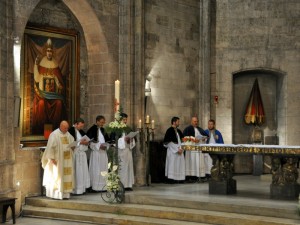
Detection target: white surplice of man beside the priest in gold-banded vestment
<box><xmin>73</xmin><ymin>129</ymin><xmax>91</xmax><ymax>194</ymax></box>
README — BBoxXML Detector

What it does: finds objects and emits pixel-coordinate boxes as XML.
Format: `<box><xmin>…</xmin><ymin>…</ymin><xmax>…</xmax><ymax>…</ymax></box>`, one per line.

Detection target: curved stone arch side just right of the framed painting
<box><xmin>62</xmin><ymin>0</ymin><xmax>114</xmax><ymax>124</ymax></box>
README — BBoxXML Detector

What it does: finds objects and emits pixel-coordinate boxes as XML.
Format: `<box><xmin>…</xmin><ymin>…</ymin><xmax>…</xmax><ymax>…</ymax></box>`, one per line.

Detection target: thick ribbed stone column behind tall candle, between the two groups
<box><xmin>119</xmin><ymin>0</ymin><xmax>146</xmax><ymax>186</ymax></box>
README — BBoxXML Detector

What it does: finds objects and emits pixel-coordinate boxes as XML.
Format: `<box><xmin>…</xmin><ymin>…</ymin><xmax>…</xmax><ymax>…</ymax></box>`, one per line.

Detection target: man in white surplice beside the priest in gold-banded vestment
<box><xmin>69</xmin><ymin>118</ymin><xmax>91</xmax><ymax>195</ymax></box>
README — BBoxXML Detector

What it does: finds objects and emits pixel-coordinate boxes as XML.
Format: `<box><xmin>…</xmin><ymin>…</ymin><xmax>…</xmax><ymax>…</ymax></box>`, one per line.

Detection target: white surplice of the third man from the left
<box><xmin>89</xmin><ymin>128</ymin><xmax>108</xmax><ymax>191</ymax></box>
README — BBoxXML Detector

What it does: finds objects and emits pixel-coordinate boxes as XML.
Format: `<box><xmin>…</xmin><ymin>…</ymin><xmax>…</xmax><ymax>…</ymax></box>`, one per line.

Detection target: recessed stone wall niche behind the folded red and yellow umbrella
<box><xmin>232</xmin><ymin>68</ymin><xmax>286</xmax><ymax>143</ymax></box>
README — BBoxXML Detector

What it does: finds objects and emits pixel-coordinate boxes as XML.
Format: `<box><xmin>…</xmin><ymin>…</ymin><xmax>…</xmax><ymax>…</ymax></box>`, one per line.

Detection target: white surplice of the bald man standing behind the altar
<box><xmin>185</xmin><ymin>128</ymin><xmax>206</xmax><ymax>177</ymax></box>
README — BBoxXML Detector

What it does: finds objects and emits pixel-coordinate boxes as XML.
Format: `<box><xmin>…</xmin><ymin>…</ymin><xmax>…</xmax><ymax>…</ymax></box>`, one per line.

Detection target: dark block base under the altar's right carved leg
<box><xmin>270</xmin><ymin>184</ymin><xmax>300</xmax><ymax>200</ymax></box>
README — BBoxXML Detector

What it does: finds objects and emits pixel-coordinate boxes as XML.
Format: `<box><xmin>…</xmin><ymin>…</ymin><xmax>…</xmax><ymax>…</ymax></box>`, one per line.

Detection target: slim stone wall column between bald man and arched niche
<box><xmin>198</xmin><ymin>0</ymin><xmax>211</xmax><ymax>127</ymax></box>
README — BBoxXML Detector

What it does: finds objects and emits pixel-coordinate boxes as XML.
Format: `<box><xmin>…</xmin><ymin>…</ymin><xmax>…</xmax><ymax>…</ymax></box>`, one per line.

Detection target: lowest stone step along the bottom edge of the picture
<box><xmin>23</xmin><ymin>205</ymin><xmax>209</xmax><ymax>225</ymax></box>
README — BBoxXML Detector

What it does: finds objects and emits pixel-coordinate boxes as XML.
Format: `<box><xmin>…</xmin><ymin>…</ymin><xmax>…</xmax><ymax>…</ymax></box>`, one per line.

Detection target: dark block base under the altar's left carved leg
<box><xmin>209</xmin><ymin>179</ymin><xmax>236</xmax><ymax>195</ymax></box>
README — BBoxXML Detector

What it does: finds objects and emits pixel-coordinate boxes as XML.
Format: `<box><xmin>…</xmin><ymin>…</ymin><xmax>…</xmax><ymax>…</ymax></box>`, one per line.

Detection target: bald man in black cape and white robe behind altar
<box><xmin>183</xmin><ymin>116</ymin><xmax>208</xmax><ymax>181</ymax></box>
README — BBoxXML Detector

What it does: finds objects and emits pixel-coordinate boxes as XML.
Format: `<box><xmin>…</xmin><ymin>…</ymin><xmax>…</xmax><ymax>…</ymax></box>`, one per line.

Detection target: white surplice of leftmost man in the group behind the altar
<box><xmin>165</xmin><ymin>132</ymin><xmax>185</xmax><ymax>180</ymax></box>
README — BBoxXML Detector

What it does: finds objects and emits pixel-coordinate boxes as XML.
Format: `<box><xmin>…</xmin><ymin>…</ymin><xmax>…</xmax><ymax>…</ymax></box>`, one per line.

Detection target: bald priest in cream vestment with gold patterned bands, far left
<box><xmin>42</xmin><ymin>121</ymin><xmax>74</xmax><ymax>199</ymax></box>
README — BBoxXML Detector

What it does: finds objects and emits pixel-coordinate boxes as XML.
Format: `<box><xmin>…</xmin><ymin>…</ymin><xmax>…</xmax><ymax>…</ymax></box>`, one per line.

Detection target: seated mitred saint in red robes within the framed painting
<box><xmin>32</xmin><ymin>38</ymin><xmax>67</xmax><ymax>134</ymax></box>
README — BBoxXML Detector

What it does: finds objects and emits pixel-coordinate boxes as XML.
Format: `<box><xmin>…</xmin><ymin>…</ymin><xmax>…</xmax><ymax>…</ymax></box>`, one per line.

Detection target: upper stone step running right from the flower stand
<box><xmin>126</xmin><ymin>195</ymin><xmax>300</xmax><ymax>220</ymax></box>
